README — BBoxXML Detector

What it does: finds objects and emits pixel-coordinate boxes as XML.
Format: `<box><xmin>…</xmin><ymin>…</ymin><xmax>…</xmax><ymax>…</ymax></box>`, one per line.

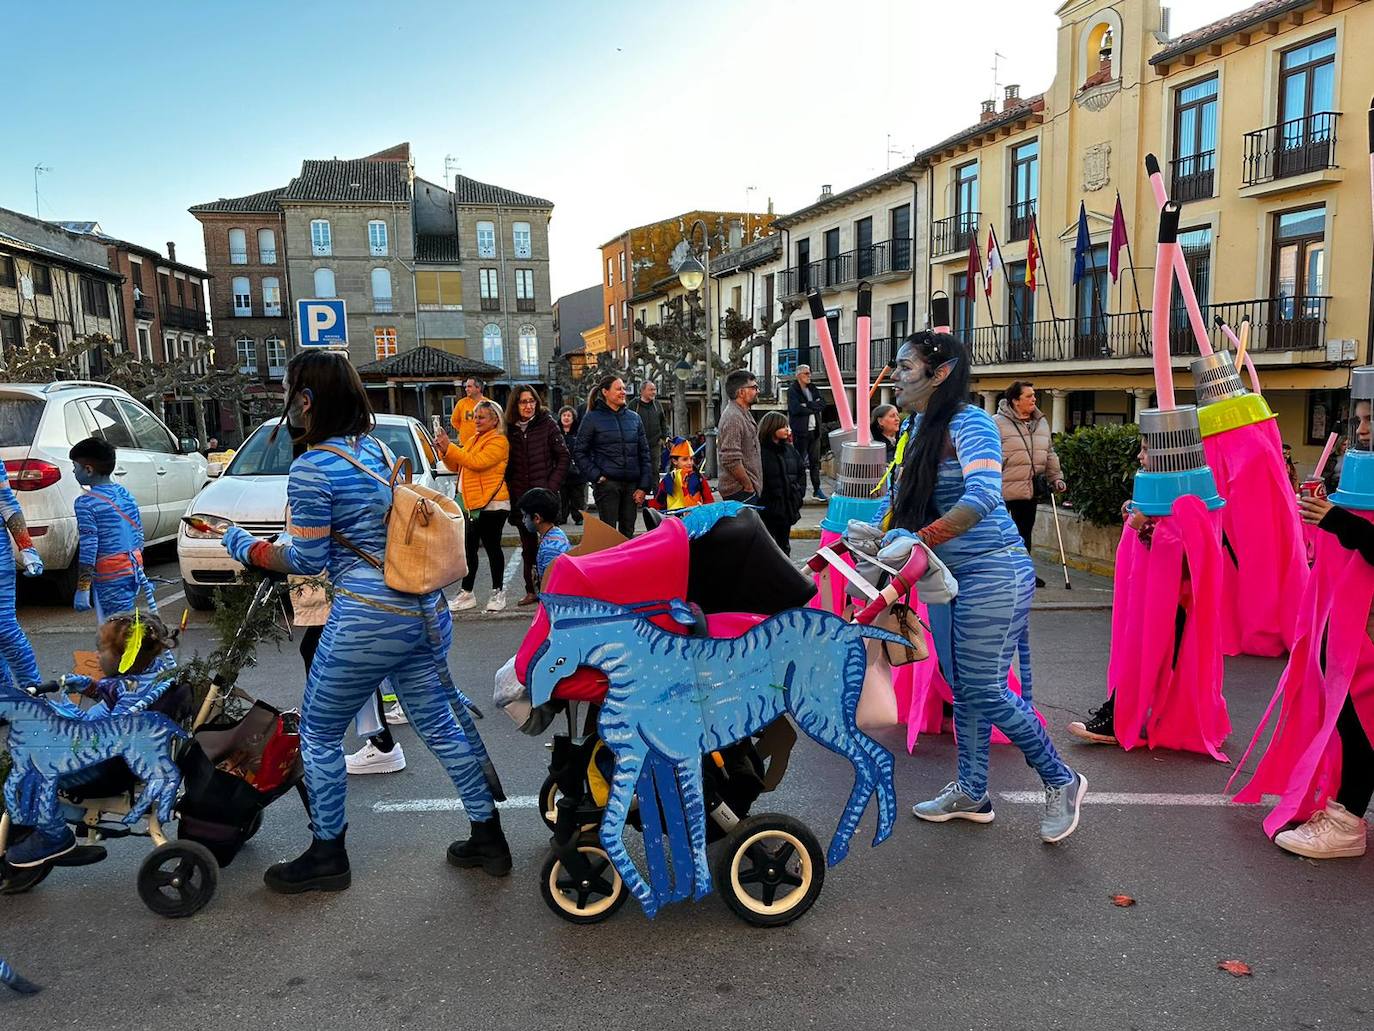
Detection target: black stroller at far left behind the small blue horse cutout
<box><xmin>0</xmin><ymin>575</ymin><xmax>305</xmax><ymax>917</ymax></box>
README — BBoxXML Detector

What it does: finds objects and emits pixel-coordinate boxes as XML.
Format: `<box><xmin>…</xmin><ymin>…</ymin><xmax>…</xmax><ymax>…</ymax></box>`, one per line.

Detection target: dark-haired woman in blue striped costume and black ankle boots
<box><xmin>224</xmin><ymin>351</ymin><xmax>511</xmax><ymax>894</ymax></box>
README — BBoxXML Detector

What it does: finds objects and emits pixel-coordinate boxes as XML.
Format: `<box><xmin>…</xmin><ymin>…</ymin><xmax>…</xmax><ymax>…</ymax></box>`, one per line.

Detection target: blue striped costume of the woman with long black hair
<box><xmin>890</xmin><ymin>406</ymin><xmax>1073</xmax><ymax>799</ymax></box>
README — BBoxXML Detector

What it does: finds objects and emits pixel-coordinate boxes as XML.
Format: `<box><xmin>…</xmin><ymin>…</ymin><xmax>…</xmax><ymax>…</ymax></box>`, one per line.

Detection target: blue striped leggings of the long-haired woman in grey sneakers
<box><xmin>932</xmin><ymin>547</ymin><xmax>1073</xmax><ymax>799</ymax></box>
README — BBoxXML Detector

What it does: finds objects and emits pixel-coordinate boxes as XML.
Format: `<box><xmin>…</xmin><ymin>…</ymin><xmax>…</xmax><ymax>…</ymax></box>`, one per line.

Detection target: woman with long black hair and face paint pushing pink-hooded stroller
<box><xmin>885</xmin><ymin>333</ymin><xmax>1087</xmax><ymax>843</ymax></box>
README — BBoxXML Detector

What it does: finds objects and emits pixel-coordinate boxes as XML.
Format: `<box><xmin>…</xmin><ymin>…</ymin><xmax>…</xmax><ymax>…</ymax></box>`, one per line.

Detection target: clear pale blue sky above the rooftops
<box><xmin>0</xmin><ymin>0</ymin><xmax>1246</xmax><ymax>297</ymax></box>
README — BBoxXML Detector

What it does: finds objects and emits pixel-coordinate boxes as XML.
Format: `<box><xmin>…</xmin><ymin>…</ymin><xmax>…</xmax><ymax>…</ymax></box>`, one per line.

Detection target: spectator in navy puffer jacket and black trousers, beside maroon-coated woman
<box><xmin>573</xmin><ymin>375</ymin><xmax>654</xmax><ymax>537</ymax></box>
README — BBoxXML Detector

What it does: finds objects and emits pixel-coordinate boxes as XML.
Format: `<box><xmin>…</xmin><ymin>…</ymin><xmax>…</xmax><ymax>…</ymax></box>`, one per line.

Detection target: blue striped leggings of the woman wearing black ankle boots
<box><xmin>301</xmin><ymin>575</ymin><xmax>496</xmax><ymax>839</ymax></box>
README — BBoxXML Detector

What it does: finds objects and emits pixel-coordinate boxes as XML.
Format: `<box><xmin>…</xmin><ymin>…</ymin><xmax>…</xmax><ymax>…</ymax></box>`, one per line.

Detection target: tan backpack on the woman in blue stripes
<box><xmin>316</xmin><ymin>444</ymin><xmax>467</xmax><ymax>594</ymax></box>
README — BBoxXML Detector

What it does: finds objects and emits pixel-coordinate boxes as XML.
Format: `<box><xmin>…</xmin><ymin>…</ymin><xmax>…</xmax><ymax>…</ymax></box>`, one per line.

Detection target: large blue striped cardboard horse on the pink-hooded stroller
<box><xmin>529</xmin><ymin>594</ymin><xmax>907</xmax><ymax>917</ymax></box>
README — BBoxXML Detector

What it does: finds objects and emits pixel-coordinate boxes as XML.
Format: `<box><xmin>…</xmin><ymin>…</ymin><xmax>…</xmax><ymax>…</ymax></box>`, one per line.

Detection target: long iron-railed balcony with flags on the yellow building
<box><xmin>966</xmin><ymin>297</ymin><xmax>1330</xmax><ymax>366</ymax></box>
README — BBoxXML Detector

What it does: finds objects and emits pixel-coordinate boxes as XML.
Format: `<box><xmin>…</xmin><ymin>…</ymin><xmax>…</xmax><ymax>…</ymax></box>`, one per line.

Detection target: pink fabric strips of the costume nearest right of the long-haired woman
<box><xmin>1107</xmin><ymin>495</ymin><xmax>1231</xmax><ymax>763</ymax></box>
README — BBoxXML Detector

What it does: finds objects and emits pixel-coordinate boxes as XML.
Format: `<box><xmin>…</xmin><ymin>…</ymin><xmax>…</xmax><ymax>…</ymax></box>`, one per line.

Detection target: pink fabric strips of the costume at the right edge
<box><xmin>1227</xmin><ymin>511</ymin><xmax>1374</xmax><ymax>837</ymax></box>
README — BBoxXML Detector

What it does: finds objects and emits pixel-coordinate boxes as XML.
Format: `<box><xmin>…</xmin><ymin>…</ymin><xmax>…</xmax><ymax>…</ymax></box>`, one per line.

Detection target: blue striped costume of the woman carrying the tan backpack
<box><xmin>225</xmin><ymin>437</ymin><xmax>496</xmax><ymax>840</ymax></box>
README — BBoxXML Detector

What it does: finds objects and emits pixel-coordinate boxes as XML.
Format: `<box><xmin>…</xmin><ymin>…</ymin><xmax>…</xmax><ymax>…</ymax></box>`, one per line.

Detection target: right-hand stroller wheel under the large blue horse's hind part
<box><xmin>712</xmin><ymin>812</ymin><xmax>826</xmax><ymax>927</ymax></box>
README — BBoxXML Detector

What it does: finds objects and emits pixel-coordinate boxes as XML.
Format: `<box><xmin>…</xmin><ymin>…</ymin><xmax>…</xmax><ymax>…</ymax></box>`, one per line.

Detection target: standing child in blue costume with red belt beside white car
<box><xmin>69</xmin><ymin>437</ymin><xmax>157</xmax><ymax>623</ymax></box>
